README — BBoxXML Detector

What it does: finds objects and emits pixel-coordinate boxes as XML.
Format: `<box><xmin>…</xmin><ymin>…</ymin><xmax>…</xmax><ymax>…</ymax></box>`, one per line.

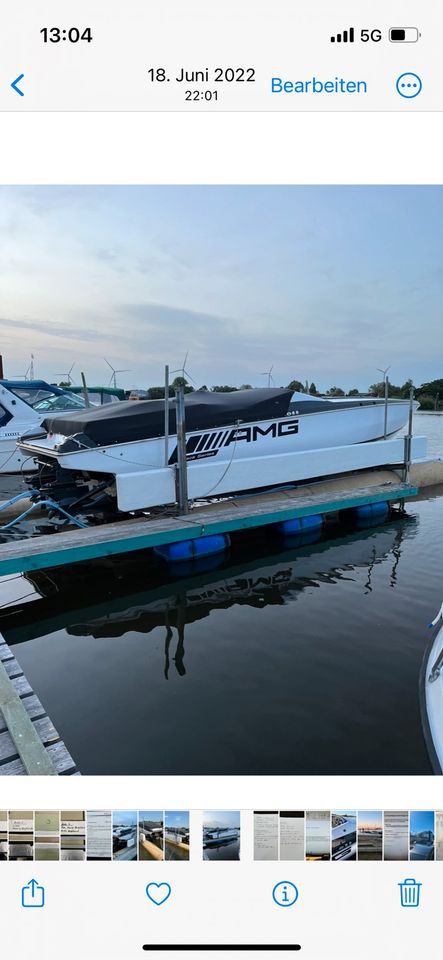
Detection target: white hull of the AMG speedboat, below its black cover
<box><xmin>20</xmin><ymin>400</ymin><xmax>420</xmax><ymax>512</ymax></box>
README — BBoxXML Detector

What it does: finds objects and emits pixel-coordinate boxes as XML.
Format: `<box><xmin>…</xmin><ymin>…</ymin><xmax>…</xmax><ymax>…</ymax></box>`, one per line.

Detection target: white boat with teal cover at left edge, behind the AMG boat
<box><xmin>0</xmin><ymin>380</ymin><xmax>89</xmax><ymax>474</ymax></box>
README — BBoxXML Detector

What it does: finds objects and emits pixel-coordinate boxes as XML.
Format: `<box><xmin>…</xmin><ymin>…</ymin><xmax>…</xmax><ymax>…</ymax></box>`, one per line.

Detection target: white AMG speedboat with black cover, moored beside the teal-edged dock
<box><xmin>19</xmin><ymin>389</ymin><xmax>418</xmax><ymax>512</ymax></box>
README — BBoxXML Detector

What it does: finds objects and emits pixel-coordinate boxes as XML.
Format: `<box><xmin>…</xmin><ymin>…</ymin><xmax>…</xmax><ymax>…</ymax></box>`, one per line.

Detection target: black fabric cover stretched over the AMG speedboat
<box><xmin>42</xmin><ymin>388</ymin><xmax>292</xmax><ymax>447</ymax></box>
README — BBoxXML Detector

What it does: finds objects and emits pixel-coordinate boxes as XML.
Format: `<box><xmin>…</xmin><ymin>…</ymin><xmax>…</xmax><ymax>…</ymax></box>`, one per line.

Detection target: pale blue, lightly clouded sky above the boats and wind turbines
<box><xmin>0</xmin><ymin>186</ymin><xmax>443</xmax><ymax>391</ymax></box>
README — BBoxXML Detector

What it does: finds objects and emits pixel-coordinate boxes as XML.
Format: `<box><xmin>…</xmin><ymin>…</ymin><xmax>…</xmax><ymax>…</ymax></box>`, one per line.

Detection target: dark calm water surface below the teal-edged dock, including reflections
<box><xmin>0</xmin><ymin>476</ymin><xmax>443</xmax><ymax>774</ymax></box>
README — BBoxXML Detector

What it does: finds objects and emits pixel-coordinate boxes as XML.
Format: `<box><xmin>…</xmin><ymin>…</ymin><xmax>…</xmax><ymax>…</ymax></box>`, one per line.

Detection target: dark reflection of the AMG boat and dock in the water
<box><xmin>5</xmin><ymin>517</ymin><xmax>415</xmax><ymax>679</ymax></box>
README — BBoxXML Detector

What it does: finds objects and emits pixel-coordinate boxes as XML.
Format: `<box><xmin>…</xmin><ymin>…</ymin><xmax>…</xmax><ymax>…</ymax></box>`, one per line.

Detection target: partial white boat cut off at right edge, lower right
<box><xmin>420</xmin><ymin>604</ymin><xmax>443</xmax><ymax>773</ymax></box>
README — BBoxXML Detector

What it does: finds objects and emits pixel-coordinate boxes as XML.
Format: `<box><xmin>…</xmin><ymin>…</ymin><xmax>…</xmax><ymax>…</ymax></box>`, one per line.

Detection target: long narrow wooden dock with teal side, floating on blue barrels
<box><xmin>0</xmin><ymin>473</ymin><xmax>418</xmax><ymax>576</ymax></box>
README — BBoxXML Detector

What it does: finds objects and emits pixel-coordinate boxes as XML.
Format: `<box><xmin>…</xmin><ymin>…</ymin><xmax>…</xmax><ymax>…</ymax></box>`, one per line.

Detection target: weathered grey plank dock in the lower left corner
<box><xmin>0</xmin><ymin>634</ymin><xmax>78</xmax><ymax>777</ymax></box>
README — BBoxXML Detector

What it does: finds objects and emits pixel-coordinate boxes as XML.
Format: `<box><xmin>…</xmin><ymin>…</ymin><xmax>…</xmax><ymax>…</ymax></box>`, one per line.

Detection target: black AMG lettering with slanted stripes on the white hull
<box><xmin>169</xmin><ymin>418</ymin><xmax>299</xmax><ymax>465</ymax></box>
